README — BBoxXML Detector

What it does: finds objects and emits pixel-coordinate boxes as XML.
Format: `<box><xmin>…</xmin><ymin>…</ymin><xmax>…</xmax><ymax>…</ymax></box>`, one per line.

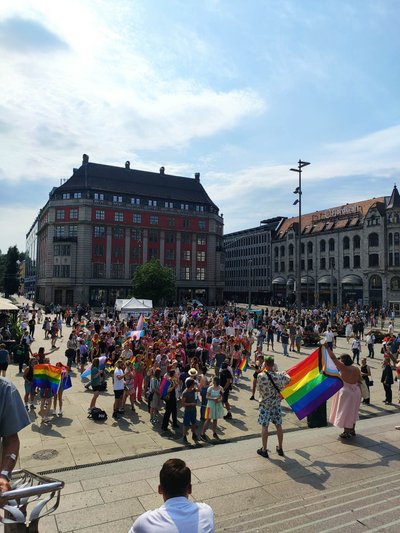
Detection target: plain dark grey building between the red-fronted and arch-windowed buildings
<box><xmin>224</xmin><ymin>217</ymin><xmax>286</xmax><ymax>304</ymax></box>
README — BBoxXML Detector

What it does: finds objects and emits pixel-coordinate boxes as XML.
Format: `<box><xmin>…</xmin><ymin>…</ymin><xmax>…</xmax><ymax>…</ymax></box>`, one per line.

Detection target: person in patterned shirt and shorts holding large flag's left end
<box><xmin>257</xmin><ymin>355</ymin><xmax>290</xmax><ymax>457</ymax></box>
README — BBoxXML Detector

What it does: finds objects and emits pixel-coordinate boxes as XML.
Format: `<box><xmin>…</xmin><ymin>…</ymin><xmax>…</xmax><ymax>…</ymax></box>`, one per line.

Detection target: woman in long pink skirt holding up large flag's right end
<box><xmin>328</xmin><ymin>349</ymin><xmax>362</xmax><ymax>439</ymax></box>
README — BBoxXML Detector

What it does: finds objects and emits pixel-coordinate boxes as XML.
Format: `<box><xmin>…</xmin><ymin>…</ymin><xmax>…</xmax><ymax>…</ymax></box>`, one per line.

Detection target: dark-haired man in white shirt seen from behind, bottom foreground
<box><xmin>129</xmin><ymin>459</ymin><xmax>214</xmax><ymax>533</ymax></box>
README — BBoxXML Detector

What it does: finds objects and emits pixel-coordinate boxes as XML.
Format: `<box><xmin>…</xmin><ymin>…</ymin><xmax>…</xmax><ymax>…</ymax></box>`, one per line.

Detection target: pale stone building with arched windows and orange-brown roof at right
<box><xmin>272</xmin><ymin>186</ymin><xmax>400</xmax><ymax>311</ymax></box>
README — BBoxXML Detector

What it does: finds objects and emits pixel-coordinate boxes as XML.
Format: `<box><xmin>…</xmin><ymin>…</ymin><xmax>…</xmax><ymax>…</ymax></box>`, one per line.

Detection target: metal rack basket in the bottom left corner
<box><xmin>0</xmin><ymin>470</ymin><xmax>64</xmax><ymax>533</ymax></box>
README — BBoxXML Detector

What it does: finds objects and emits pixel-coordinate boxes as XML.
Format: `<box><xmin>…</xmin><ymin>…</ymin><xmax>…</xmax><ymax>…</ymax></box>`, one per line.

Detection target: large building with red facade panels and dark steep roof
<box><xmin>36</xmin><ymin>155</ymin><xmax>224</xmax><ymax>306</ymax></box>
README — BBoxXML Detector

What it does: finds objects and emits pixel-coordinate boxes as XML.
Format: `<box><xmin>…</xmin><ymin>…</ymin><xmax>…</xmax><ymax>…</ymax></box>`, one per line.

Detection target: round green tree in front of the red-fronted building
<box><xmin>132</xmin><ymin>259</ymin><xmax>175</xmax><ymax>305</ymax></box>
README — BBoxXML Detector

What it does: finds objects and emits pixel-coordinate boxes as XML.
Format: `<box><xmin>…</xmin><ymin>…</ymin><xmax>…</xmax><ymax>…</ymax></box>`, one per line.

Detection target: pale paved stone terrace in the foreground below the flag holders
<box><xmin>35</xmin><ymin>414</ymin><xmax>400</xmax><ymax>533</ymax></box>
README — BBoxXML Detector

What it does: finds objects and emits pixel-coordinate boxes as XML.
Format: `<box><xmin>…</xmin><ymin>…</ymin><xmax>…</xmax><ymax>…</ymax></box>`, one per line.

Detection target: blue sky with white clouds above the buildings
<box><xmin>0</xmin><ymin>0</ymin><xmax>400</xmax><ymax>252</ymax></box>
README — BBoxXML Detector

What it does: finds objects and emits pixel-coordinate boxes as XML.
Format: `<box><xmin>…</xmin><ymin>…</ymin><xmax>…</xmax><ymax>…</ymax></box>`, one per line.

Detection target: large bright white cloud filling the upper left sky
<box><xmin>0</xmin><ymin>1</ymin><xmax>266</xmax><ymax>184</ymax></box>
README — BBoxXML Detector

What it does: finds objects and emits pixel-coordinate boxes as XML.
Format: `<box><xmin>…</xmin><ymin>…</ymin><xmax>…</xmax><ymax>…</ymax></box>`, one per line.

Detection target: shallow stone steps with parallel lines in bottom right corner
<box><xmin>217</xmin><ymin>472</ymin><xmax>400</xmax><ymax>533</ymax></box>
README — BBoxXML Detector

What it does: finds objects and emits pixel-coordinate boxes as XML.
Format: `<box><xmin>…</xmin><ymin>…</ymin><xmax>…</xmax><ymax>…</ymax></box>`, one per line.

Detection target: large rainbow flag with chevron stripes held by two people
<box><xmin>281</xmin><ymin>346</ymin><xmax>343</xmax><ymax>420</ymax></box>
